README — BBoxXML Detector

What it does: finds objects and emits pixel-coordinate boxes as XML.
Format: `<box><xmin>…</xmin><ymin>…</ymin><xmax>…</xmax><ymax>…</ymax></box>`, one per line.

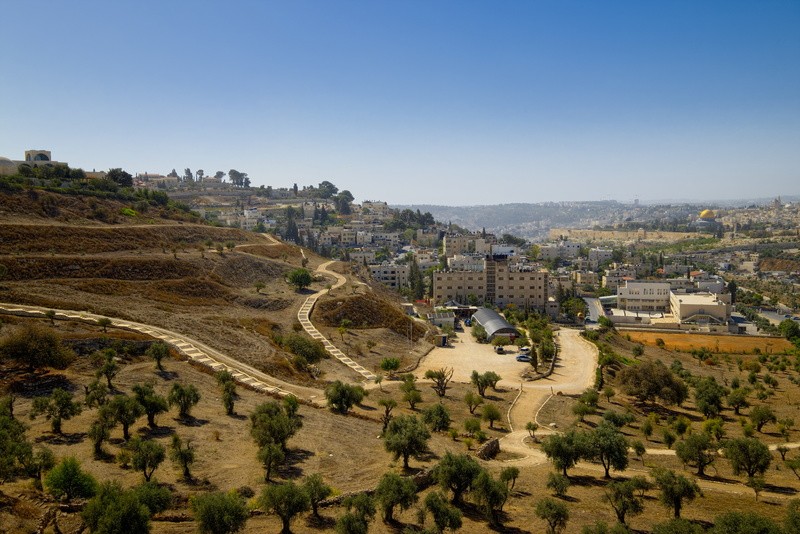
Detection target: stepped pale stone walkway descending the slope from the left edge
<box><xmin>0</xmin><ymin>303</ymin><xmax>324</xmax><ymax>406</ymax></box>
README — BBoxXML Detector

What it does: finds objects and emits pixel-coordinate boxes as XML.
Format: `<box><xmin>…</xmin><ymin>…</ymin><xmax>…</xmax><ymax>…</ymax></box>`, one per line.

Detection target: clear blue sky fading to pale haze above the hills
<box><xmin>0</xmin><ymin>0</ymin><xmax>800</xmax><ymax>205</ymax></box>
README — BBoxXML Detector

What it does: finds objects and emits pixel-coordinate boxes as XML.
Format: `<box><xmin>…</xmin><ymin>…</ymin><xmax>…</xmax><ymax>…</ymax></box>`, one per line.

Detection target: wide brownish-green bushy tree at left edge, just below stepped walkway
<box><xmin>0</xmin><ymin>325</ymin><xmax>75</xmax><ymax>372</ymax></box>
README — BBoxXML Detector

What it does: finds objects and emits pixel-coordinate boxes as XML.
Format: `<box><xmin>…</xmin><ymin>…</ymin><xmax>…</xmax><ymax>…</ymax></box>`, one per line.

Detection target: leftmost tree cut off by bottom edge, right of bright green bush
<box><xmin>81</xmin><ymin>481</ymin><xmax>150</xmax><ymax>534</ymax></box>
